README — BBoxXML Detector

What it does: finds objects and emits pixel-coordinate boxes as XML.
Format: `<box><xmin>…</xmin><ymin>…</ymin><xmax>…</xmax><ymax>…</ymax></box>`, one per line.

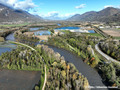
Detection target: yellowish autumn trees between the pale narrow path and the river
<box><xmin>37</xmin><ymin>45</ymin><xmax>89</xmax><ymax>90</ymax></box>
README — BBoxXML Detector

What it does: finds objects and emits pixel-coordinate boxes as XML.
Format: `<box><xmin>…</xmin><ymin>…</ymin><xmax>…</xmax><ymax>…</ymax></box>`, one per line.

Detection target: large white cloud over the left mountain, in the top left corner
<box><xmin>0</xmin><ymin>0</ymin><xmax>36</xmax><ymax>10</ymax></box>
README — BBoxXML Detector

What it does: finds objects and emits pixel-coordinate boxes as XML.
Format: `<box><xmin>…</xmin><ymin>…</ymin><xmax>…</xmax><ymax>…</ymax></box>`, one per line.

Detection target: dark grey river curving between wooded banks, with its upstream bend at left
<box><xmin>0</xmin><ymin>30</ymin><xmax>107</xmax><ymax>90</ymax></box>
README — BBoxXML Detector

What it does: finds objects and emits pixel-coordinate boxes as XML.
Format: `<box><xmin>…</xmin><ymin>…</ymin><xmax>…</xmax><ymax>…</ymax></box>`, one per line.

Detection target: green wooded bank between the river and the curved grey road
<box><xmin>45</xmin><ymin>33</ymin><xmax>120</xmax><ymax>86</ymax></box>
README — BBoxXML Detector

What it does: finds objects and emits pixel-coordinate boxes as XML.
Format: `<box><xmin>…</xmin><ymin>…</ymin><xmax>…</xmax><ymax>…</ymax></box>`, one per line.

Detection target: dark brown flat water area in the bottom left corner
<box><xmin>0</xmin><ymin>70</ymin><xmax>41</xmax><ymax>90</ymax></box>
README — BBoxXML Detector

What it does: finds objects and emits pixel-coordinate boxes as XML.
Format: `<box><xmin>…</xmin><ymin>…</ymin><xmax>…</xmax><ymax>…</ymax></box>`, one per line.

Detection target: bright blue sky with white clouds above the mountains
<box><xmin>0</xmin><ymin>0</ymin><xmax>120</xmax><ymax>19</ymax></box>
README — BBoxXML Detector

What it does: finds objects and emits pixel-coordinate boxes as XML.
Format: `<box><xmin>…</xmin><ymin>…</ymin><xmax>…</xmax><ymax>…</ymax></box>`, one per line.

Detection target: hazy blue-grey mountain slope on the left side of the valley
<box><xmin>0</xmin><ymin>4</ymin><xmax>42</xmax><ymax>22</ymax></box>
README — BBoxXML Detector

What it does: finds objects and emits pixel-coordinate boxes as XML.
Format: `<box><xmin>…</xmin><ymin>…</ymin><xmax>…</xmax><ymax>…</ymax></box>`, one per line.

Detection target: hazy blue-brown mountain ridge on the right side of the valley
<box><xmin>67</xmin><ymin>7</ymin><xmax>120</xmax><ymax>22</ymax></box>
